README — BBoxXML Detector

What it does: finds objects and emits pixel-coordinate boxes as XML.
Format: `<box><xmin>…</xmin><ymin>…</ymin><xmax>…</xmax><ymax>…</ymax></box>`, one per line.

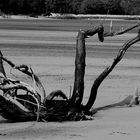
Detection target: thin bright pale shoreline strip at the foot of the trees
<box><xmin>0</xmin><ymin>13</ymin><xmax>140</xmax><ymax>20</ymax></box>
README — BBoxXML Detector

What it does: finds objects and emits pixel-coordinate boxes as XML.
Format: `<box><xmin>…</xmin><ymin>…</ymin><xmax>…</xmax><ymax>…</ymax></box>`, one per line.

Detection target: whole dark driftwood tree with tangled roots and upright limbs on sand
<box><xmin>0</xmin><ymin>24</ymin><xmax>140</xmax><ymax>121</ymax></box>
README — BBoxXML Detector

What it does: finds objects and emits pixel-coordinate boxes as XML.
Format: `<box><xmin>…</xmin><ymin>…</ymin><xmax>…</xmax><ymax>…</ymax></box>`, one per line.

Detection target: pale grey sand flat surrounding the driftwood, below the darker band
<box><xmin>0</xmin><ymin>18</ymin><xmax>140</xmax><ymax>140</ymax></box>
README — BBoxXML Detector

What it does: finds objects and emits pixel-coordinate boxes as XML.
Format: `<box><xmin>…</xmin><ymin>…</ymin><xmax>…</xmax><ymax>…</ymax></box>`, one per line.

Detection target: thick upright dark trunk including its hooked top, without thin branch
<box><xmin>70</xmin><ymin>26</ymin><xmax>103</xmax><ymax>108</ymax></box>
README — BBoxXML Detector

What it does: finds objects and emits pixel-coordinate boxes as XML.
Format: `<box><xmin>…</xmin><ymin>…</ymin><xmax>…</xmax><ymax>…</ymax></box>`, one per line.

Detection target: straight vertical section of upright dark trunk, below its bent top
<box><xmin>71</xmin><ymin>31</ymin><xmax>86</xmax><ymax>108</ymax></box>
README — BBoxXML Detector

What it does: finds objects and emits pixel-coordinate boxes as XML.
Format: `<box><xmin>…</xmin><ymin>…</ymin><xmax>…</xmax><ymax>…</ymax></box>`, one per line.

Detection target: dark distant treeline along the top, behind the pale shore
<box><xmin>0</xmin><ymin>0</ymin><xmax>140</xmax><ymax>16</ymax></box>
